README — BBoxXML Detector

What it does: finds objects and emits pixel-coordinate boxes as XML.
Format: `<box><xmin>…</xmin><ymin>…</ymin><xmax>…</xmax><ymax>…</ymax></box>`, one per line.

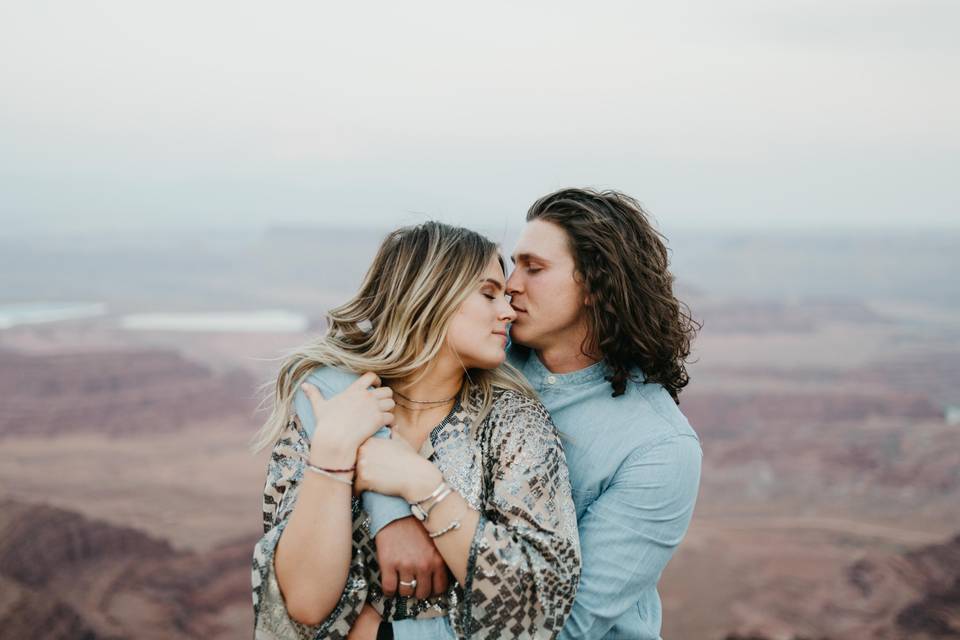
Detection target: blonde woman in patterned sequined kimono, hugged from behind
<box><xmin>253</xmin><ymin>222</ymin><xmax>580</xmax><ymax>638</ymax></box>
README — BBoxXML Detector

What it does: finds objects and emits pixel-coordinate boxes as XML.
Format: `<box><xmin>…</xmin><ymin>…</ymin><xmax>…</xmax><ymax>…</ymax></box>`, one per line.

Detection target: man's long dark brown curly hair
<box><xmin>527</xmin><ymin>189</ymin><xmax>701</xmax><ymax>404</ymax></box>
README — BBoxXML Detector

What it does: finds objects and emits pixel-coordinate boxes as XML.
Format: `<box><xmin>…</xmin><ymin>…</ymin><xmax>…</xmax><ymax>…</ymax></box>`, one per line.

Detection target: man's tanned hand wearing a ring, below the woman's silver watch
<box><xmin>374</xmin><ymin>516</ymin><xmax>449</xmax><ymax>600</ymax></box>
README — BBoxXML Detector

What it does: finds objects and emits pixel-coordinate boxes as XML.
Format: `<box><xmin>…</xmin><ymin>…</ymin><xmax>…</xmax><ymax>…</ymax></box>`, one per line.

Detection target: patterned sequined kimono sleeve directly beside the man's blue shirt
<box><xmin>451</xmin><ymin>393</ymin><xmax>580</xmax><ymax>638</ymax></box>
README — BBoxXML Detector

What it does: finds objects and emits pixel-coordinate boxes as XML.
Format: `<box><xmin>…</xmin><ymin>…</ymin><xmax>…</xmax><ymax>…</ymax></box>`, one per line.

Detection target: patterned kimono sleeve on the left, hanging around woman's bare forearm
<box><xmin>251</xmin><ymin>380</ymin><xmax>369</xmax><ymax>640</ymax></box>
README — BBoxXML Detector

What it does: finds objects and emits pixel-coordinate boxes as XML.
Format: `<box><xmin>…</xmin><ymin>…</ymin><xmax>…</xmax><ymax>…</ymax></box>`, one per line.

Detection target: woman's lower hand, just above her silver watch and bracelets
<box><xmin>353</xmin><ymin>437</ymin><xmax>443</xmax><ymax>502</ymax></box>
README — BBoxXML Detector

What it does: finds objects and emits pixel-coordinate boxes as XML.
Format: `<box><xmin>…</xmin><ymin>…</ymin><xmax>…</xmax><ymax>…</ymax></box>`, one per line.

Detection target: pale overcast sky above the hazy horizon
<box><xmin>0</xmin><ymin>0</ymin><xmax>960</xmax><ymax>233</ymax></box>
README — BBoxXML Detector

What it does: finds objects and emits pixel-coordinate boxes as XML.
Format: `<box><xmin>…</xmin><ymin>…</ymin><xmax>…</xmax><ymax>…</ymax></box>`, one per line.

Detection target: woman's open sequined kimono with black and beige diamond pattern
<box><xmin>252</xmin><ymin>378</ymin><xmax>580</xmax><ymax>639</ymax></box>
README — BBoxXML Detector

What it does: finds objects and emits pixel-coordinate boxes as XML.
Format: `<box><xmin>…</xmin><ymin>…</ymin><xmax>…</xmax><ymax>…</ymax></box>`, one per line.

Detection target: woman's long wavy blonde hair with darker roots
<box><xmin>252</xmin><ymin>222</ymin><xmax>534</xmax><ymax>451</ymax></box>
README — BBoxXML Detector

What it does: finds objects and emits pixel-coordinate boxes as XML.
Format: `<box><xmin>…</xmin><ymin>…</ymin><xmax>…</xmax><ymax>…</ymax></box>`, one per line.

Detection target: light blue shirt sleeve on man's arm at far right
<box><xmin>560</xmin><ymin>435</ymin><xmax>702</xmax><ymax>640</ymax></box>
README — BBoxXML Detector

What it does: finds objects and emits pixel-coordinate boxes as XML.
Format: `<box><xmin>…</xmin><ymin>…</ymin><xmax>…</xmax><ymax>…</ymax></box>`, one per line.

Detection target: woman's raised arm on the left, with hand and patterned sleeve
<box><xmin>254</xmin><ymin>374</ymin><xmax>393</xmax><ymax>636</ymax></box>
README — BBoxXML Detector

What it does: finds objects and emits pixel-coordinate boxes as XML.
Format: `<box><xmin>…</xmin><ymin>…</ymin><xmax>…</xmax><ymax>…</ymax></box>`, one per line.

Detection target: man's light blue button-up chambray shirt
<box><xmin>364</xmin><ymin>348</ymin><xmax>702</xmax><ymax>640</ymax></box>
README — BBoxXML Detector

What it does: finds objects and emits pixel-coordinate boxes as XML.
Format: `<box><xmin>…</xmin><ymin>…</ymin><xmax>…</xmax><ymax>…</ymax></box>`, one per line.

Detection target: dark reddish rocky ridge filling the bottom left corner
<box><xmin>0</xmin><ymin>500</ymin><xmax>254</xmax><ymax>640</ymax></box>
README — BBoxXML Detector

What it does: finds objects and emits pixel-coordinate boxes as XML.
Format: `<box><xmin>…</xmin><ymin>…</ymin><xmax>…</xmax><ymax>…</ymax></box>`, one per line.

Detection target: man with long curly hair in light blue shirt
<box><xmin>364</xmin><ymin>189</ymin><xmax>702</xmax><ymax>640</ymax></box>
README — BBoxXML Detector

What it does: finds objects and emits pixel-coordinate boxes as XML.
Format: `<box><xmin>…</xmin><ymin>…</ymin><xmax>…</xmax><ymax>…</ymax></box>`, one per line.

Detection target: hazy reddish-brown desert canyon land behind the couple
<box><xmin>0</xmin><ymin>230</ymin><xmax>960</xmax><ymax>640</ymax></box>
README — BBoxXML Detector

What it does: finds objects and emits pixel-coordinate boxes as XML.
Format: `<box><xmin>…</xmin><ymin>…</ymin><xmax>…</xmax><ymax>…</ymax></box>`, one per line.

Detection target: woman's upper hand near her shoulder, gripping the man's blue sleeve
<box><xmin>300</xmin><ymin>372</ymin><xmax>395</xmax><ymax>468</ymax></box>
